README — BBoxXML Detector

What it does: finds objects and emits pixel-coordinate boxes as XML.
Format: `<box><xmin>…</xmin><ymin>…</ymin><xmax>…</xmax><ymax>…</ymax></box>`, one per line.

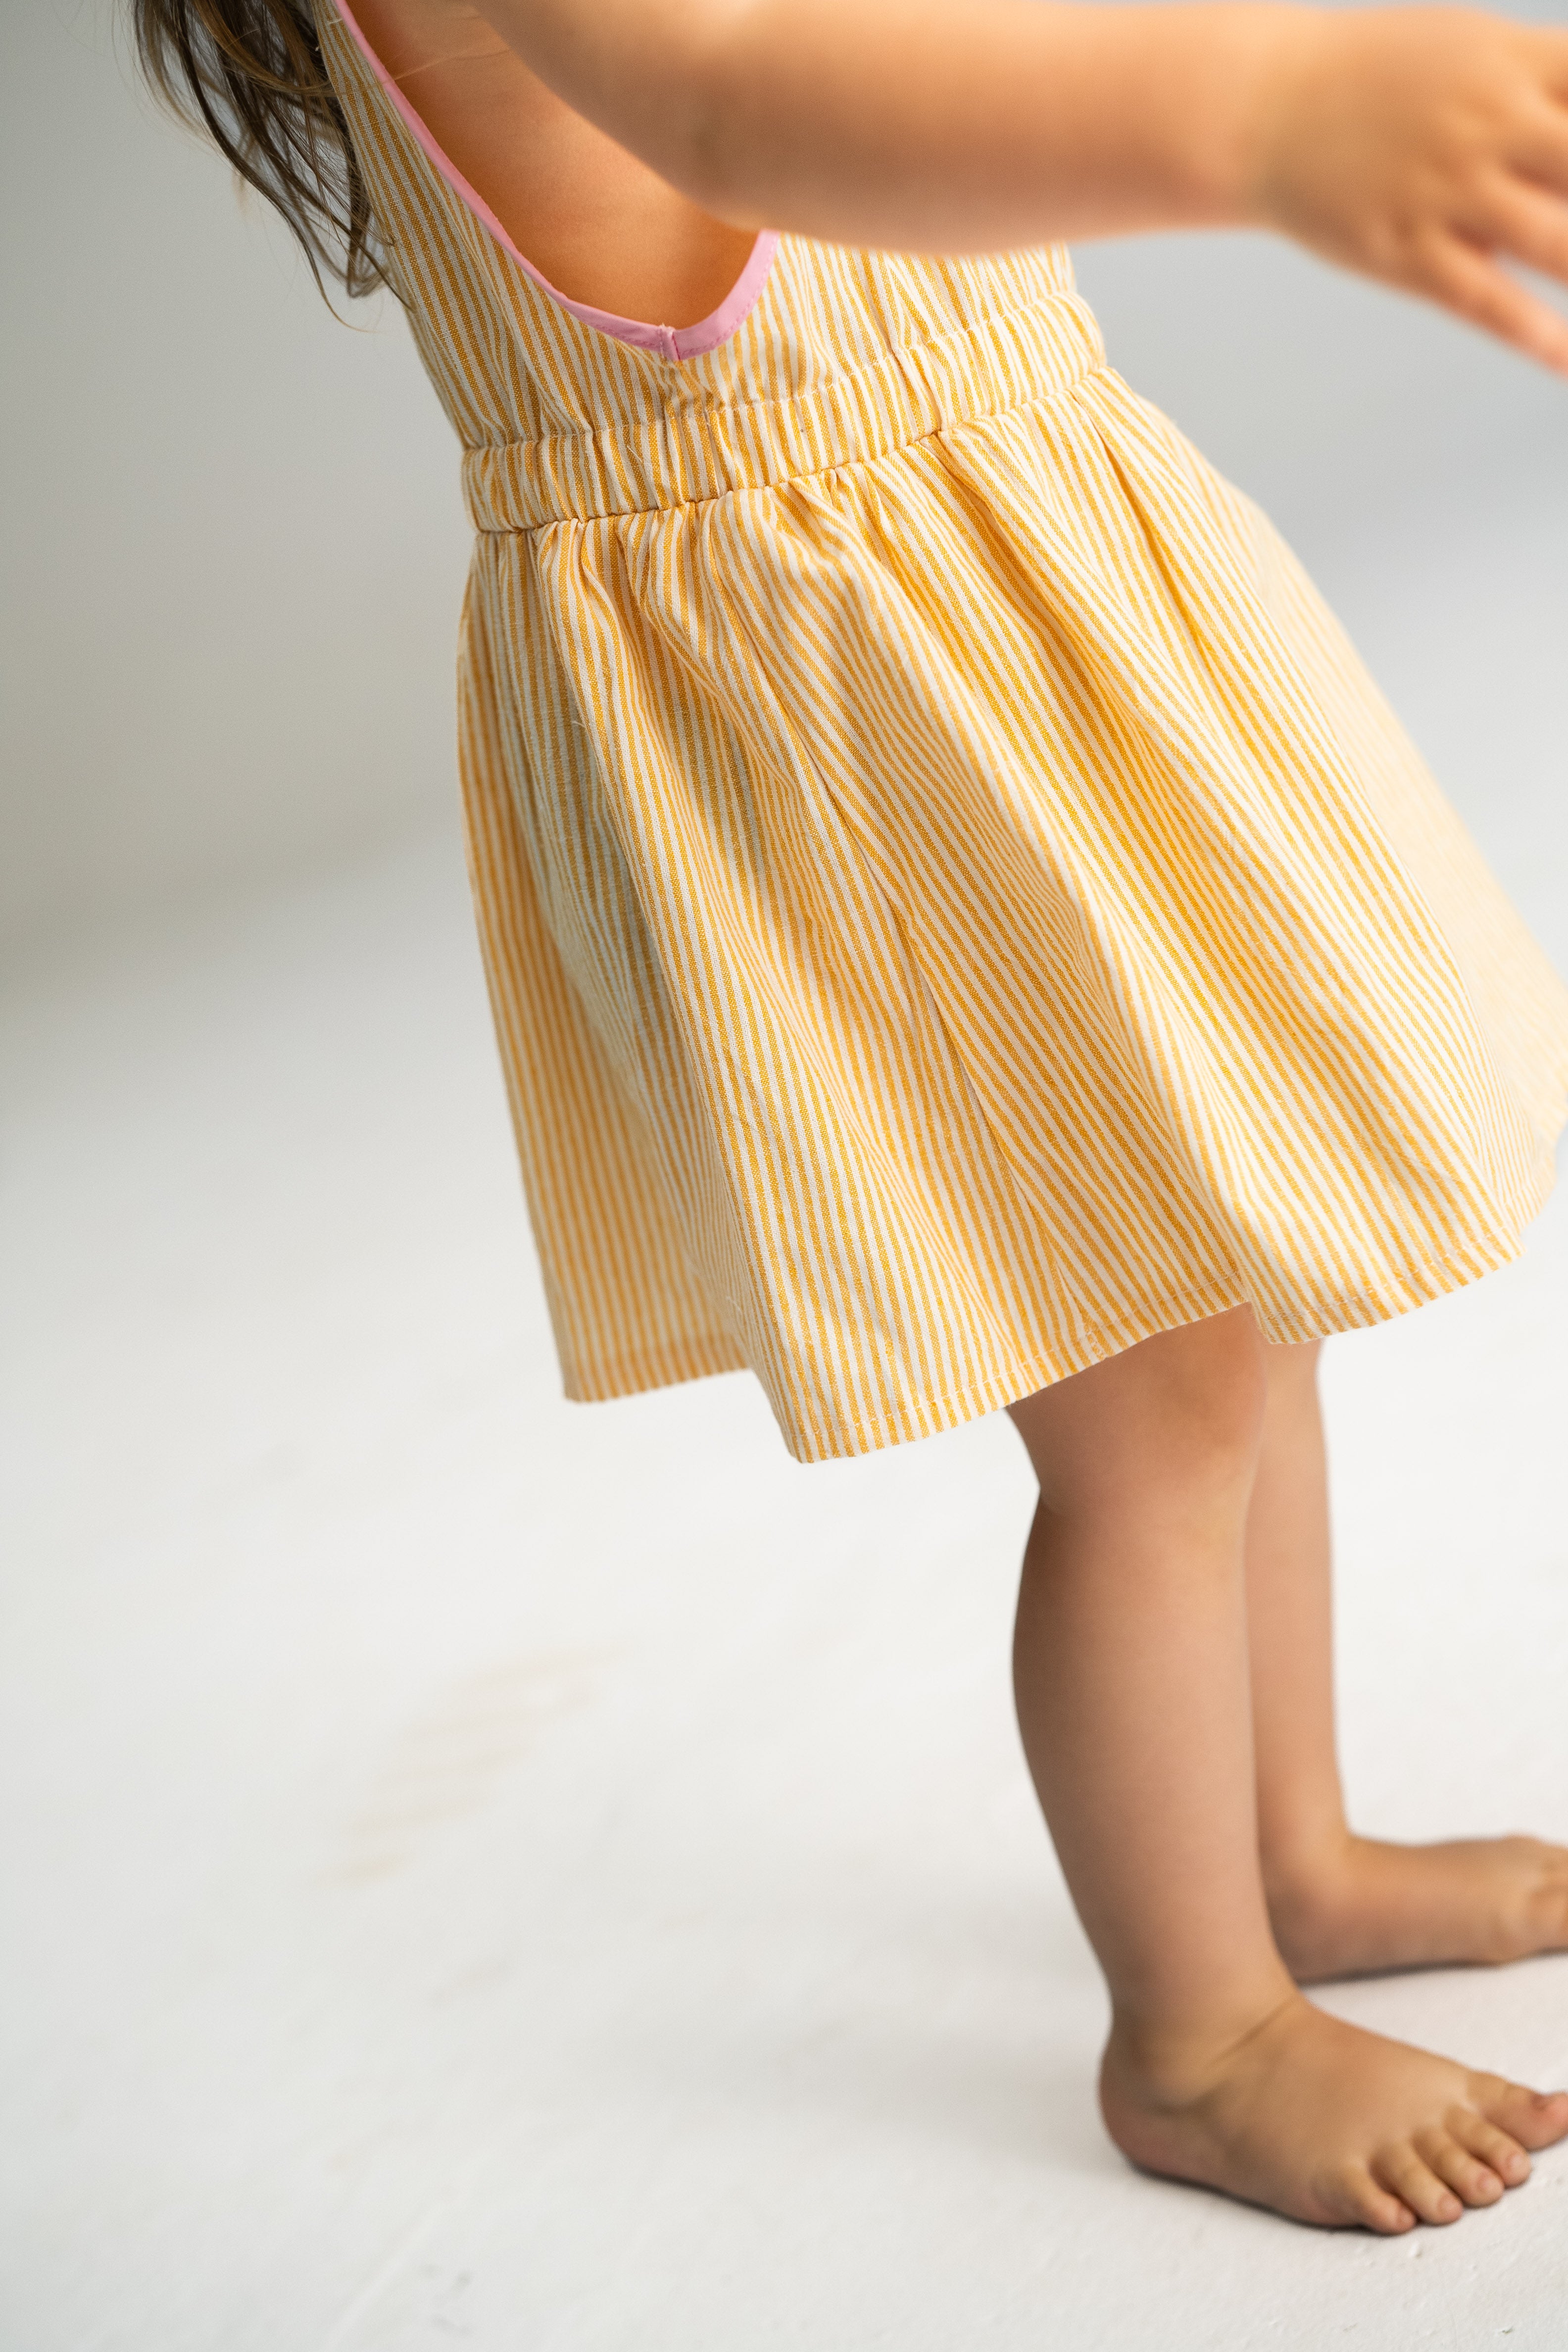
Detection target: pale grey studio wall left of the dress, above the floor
<box><xmin>0</xmin><ymin>0</ymin><xmax>465</xmax><ymax>941</ymax></box>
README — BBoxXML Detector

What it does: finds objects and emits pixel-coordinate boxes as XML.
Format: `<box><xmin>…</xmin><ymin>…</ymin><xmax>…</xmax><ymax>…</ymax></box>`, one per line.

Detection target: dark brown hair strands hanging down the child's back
<box><xmin>129</xmin><ymin>0</ymin><xmax>386</xmax><ymax>294</ymax></box>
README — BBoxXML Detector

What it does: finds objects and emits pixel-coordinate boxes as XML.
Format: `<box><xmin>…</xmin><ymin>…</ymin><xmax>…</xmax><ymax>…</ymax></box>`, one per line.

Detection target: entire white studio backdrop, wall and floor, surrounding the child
<box><xmin>0</xmin><ymin>0</ymin><xmax>1568</xmax><ymax>2352</ymax></box>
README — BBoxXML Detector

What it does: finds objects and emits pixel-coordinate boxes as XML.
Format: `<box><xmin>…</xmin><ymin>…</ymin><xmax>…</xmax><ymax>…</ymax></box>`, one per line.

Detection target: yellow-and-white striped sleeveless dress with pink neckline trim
<box><xmin>320</xmin><ymin>0</ymin><xmax>1568</xmax><ymax>1461</ymax></box>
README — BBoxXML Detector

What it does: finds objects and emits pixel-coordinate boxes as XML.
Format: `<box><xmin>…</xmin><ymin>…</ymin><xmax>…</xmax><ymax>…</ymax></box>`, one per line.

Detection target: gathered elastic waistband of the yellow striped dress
<box><xmin>463</xmin><ymin>292</ymin><xmax>1105</xmax><ymax>532</ymax></box>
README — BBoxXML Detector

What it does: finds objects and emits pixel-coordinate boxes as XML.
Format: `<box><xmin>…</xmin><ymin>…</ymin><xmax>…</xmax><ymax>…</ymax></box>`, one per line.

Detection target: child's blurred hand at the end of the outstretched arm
<box><xmin>1253</xmin><ymin>7</ymin><xmax>1568</xmax><ymax>374</ymax></box>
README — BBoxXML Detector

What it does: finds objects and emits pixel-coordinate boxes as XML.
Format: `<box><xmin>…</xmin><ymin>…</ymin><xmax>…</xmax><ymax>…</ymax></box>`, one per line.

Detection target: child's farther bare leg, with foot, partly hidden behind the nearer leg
<box><xmin>1246</xmin><ymin>1341</ymin><xmax>1568</xmax><ymax>1980</ymax></box>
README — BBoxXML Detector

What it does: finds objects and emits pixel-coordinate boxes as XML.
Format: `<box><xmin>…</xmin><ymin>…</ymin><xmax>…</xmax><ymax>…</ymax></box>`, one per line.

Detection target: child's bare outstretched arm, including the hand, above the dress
<box><xmin>480</xmin><ymin>0</ymin><xmax>1568</xmax><ymax>374</ymax></box>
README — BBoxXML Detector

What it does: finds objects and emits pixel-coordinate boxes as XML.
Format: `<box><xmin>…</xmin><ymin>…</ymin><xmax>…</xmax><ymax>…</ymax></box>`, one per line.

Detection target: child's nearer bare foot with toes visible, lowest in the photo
<box><xmin>1100</xmin><ymin>1995</ymin><xmax>1568</xmax><ymax>2237</ymax></box>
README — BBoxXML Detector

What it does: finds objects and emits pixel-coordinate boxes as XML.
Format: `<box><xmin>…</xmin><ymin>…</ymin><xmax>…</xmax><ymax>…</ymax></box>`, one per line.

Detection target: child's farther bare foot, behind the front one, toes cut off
<box><xmin>1267</xmin><ymin>1837</ymin><xmax>1568</xmax><ymax>1983</ymax></box>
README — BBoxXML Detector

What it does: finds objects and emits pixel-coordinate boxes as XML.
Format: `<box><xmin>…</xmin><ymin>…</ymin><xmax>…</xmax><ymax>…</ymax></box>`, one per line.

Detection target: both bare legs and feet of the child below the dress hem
<box><xmin>1011</xmin><ymin>1308</ymin><xmax>1568</xmax><ymax>2234</ymax></box>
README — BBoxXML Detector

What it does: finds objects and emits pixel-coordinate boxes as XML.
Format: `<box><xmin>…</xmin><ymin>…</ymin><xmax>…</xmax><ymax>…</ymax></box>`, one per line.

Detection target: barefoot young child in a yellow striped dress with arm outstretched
<box><xmin>134</xmin><ymin>0</ymin><xmax>1568</xmax><ymax>2232</ymax></box>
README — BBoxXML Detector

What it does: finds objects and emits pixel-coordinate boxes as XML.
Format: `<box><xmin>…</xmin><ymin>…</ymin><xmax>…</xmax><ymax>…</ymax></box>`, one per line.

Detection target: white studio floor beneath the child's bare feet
<box><xmin>0</xmin><ymin>505</ymin><xmax>1568</xmax><ymax>2352</ymax></box>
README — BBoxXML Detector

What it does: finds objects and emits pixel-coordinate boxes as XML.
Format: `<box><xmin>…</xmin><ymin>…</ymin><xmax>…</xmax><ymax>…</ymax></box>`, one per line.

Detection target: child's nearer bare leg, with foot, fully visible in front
<box><xmin>1011</xmin><ymin>1310</ymin><xmax>1568</xmax><ymax>2232</ymax></box>
